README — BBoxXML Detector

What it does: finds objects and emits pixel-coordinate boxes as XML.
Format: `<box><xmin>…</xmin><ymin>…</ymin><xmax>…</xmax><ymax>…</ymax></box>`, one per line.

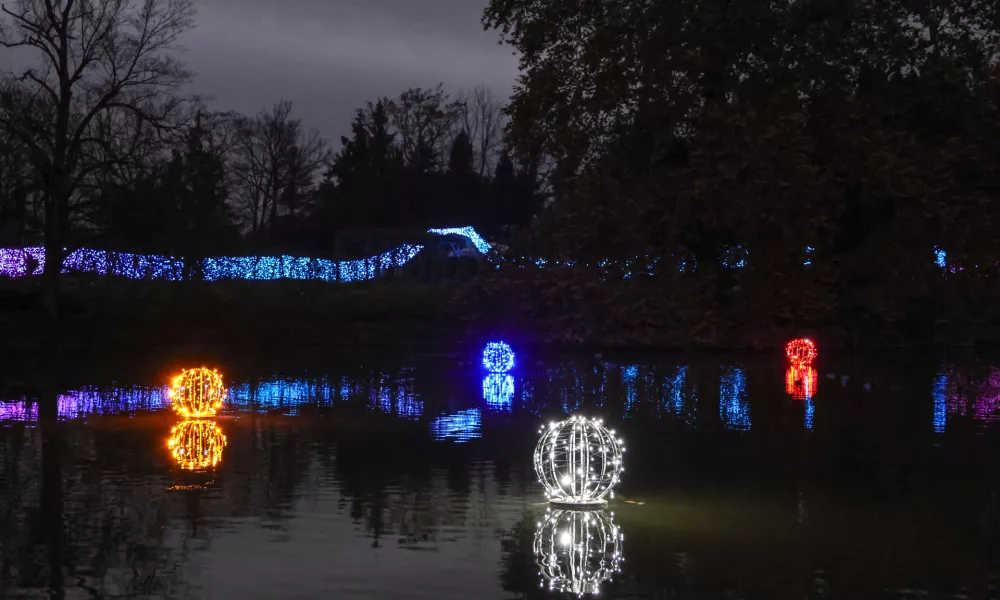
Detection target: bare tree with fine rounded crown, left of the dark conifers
<box><xmin>233</xmin><ymin>100</ymin><xmax>329</xmax><ymax>233</ymax></box>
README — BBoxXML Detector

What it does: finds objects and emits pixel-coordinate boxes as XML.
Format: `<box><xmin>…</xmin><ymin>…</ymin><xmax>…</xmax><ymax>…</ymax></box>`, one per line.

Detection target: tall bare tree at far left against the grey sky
<box><xmin>0</xmin><ymin>0</ymin><xmax>194</xmax><ymax>318</ymax></box>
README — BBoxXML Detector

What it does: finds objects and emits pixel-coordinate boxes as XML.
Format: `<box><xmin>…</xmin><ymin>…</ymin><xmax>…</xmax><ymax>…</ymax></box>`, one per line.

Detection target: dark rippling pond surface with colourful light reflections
<box><xmin>0</xmin><ymin>352</ymin><xmax>1000</xmax><ymax>599</ymax></box>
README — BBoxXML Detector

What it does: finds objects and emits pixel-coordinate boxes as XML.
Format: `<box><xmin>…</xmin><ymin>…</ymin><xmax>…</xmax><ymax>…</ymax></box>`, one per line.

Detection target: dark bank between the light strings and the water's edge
<box><xmin>0</xmin><ymin>279</ymin><xmax>1000</xmax><ymax>355</ymax></box>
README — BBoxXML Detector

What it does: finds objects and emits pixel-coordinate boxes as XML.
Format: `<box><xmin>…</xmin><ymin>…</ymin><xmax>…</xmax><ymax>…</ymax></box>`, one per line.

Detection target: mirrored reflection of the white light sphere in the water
<box><xmin>534</xmin><ymin>509</ymin><xmax>625</xmax><ymax>596</ymax></box>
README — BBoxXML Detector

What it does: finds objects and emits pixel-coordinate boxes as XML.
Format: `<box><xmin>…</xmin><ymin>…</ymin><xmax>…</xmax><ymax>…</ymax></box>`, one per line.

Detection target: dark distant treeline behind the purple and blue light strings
<box><xmin>0</xmin><ymin>82</ymin><xmax>541</xmax><ymax>257</ymax></box>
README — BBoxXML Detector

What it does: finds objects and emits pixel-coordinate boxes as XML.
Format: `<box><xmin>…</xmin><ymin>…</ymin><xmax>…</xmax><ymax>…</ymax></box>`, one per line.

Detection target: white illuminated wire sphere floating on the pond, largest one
<box><xmin>535</xmin><ymin>415</ymin><xmax>625</xmax><ymax>506</ymax></box>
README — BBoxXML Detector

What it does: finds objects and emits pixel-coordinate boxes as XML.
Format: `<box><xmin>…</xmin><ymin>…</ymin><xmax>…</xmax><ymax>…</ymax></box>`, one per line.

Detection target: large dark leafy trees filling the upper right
<box><xmin>474</xmin><ymin>0</ymin><xmax>1000</xmax><ymax>346</ymax></box>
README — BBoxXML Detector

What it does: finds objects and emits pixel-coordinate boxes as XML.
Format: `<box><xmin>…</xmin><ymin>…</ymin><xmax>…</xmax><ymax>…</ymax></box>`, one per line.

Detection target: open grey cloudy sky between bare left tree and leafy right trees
<box><xmin>180</xmin><ymin>0</ymin><xmax>517</xmax><ymax>145</ymax></box>
